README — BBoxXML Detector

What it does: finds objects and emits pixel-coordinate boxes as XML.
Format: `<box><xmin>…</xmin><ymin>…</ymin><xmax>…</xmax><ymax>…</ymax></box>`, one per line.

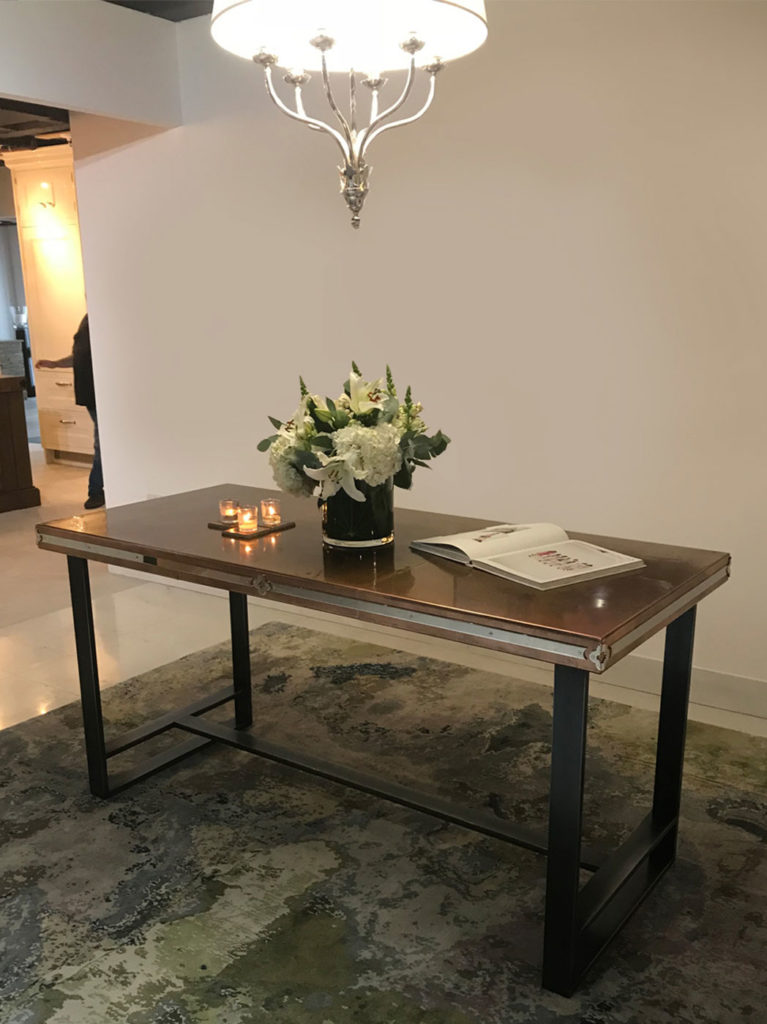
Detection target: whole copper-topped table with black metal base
<box><xmin>37</xmin><ymin>483</ymin><xmax>729</xmax><ymax>995</ymax></box>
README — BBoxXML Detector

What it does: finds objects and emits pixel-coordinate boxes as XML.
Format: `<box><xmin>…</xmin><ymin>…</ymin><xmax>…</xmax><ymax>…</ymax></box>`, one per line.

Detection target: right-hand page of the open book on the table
<box><xmin>477</xmin><ymin>541</ymin><xmax>643</xmax><ymax>585</ymax></box>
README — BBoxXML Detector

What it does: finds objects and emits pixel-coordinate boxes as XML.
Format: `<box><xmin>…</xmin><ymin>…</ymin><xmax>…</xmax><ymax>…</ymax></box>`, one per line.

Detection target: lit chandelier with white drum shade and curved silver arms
<box><xmin>211</xmin><ymin>0</ymin><xmax>487</xmax><ymax>227</ymax></box>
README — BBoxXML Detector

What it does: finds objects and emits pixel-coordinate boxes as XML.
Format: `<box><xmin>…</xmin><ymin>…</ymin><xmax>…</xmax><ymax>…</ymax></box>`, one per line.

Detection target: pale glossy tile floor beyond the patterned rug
<box><xmin>0</xmin><ymin>444</ymin><xmax>767</xmax><ymax>735</ymax></box>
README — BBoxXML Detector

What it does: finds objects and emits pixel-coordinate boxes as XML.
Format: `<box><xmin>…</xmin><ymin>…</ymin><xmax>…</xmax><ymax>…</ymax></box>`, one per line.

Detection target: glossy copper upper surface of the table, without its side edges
<box><xmin>38</xmin><ymin>483</ymin><xmax>729</xmax><ymax>659</ymax></box>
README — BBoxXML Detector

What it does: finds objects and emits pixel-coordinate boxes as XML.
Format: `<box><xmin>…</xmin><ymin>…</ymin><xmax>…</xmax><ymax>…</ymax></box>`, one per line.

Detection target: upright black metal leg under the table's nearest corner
<box><xmin>543</xmin><ymin>665</ymin><xmax>589</xmax><ymax>994</ymax></box>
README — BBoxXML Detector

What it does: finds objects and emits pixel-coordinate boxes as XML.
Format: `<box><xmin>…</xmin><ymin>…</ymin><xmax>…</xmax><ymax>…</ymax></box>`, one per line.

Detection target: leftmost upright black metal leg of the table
<box><xmin>67</xmin><ymin>555</ymin><xmax>110</xmax><ymax>797</ymax></box>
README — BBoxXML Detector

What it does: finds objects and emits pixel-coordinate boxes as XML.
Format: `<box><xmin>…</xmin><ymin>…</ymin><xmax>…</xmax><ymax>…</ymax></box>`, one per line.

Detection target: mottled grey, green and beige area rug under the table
<box><xmin>0</xmin><ymin>624</ymin><xmax>767</xmax><ymax>1024</ymax></box>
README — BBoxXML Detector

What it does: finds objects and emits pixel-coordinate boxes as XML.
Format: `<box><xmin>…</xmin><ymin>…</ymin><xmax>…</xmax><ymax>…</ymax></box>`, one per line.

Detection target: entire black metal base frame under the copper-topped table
<box><xmin>64</xmin><ymin>539</ymin><xmax>710</xmax><ymax>995</ymax></box>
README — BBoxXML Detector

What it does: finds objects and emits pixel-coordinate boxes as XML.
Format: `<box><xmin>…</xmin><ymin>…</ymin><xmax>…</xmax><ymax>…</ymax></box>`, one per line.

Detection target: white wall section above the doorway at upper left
<box><xmin>0</xmin><ymin>0</ymin><xmax>179</xmax><ymax>125</ymax></box>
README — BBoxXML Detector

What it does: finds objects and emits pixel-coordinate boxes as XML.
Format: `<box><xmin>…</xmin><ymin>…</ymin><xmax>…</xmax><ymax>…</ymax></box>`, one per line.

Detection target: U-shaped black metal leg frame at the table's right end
<box><xmin>543</xmin><ymin>607</ymin><xmax>695</xmax><ymax>995</ymax></box>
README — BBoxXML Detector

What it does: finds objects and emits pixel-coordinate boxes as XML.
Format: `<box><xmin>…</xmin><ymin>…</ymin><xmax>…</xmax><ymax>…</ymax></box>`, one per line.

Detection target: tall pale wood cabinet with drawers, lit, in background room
<box><xmin>3</xmin><ymin>144</ymin><xmax>93</xmax><ymax>460</ymax></box>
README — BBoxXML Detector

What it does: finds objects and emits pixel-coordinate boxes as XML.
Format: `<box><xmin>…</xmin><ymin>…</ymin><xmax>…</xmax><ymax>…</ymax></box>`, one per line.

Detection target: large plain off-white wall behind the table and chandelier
<box><xmin>13</xmin><ymin>0</ymin><xmax>767</xmax><ymax>696</ymax></box>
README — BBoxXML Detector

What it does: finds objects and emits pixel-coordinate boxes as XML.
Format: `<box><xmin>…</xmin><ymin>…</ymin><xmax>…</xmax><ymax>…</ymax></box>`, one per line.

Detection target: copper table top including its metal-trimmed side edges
<box><xmin>37</xmin><ymin>483</ymin><xmax>729</xmax><ymax>672</ymax></box>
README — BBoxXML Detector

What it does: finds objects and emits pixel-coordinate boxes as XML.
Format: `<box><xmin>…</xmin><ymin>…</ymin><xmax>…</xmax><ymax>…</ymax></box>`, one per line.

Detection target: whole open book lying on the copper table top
<box><xmin>411</xmin><ymin>522</ymin><xmax>644</xmax><ymax>590</ymax></box>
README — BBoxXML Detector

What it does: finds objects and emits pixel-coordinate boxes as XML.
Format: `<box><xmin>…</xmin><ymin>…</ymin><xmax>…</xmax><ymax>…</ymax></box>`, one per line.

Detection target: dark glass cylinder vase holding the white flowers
<box><xmin>323</xmin><ymin>478</ymin><xmax>394</xmax><ymax>548</ymax></box>
